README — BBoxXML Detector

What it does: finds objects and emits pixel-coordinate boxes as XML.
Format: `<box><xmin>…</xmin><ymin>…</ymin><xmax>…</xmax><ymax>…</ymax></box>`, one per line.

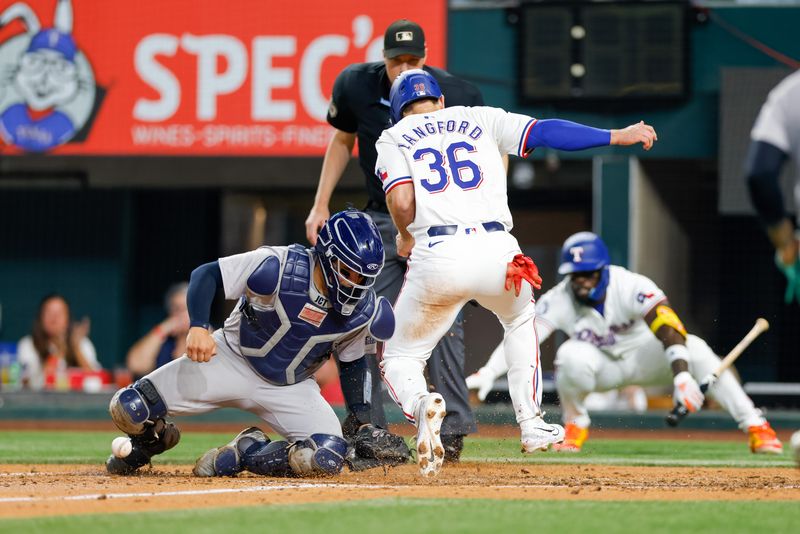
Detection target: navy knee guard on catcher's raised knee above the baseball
<box><xmin>108</xmin><ymin>378</ymin><xmax>167</xmax><ymax>436</ymax></box>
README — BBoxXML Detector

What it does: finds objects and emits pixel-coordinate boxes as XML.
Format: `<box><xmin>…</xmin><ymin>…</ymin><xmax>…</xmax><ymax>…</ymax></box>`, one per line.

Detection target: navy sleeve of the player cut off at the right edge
<box><xmin>745</xmin><ymin>141</ymin><xmax>788</xmax><ymax>226</ymax></box>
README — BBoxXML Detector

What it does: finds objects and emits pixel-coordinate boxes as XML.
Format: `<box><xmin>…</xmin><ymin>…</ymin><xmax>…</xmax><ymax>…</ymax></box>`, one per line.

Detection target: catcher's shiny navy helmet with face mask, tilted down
<box><xmin>314</xmin><ymin>208</ymin><xmax>384</xmax><ymax>315</ymax></box>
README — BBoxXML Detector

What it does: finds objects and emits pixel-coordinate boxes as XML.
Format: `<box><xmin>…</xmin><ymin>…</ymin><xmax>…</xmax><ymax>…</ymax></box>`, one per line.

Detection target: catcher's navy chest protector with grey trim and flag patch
<box><xmin>239</xmin><ymin>245</ymin><xmax>376</xmax><ymax>385</ymax></box>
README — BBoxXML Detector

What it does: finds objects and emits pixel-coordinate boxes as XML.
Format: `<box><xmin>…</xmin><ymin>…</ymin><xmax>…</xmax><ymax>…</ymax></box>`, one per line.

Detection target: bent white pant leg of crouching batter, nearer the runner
<box><xmin>555</xmin><ymin>339</ymin><xmax>625</xmax><ymax>428</ymax></box>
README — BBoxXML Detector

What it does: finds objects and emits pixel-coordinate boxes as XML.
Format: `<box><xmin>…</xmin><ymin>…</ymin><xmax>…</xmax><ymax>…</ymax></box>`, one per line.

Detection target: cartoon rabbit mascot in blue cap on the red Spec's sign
<box><xmin>0</xmin><ymin>0</ymin><xmax>103</xmax><ymax>152</ymax></box>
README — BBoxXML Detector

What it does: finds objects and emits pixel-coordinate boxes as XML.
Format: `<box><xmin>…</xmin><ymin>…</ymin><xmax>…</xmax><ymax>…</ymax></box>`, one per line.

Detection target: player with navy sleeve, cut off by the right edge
<box><xmin>745</xmin><ymin>72</ymin><xmax>800</xmax><ymax>465</ymax></box>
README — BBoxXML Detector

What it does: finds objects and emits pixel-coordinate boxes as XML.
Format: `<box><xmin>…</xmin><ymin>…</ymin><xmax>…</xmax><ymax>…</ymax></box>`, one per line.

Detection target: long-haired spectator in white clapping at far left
<box><xmin>17</xmin><ymin>293</ymin><xmax>100</xmax><ymax>390</ymax></box>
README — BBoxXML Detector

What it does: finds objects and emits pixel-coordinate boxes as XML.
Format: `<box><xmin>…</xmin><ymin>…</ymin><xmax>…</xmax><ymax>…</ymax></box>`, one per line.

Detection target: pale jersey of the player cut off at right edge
<box><xmin>750</xmin><ymin>71</ymin><xmax>800</xmax><ymax>211</ymax></box>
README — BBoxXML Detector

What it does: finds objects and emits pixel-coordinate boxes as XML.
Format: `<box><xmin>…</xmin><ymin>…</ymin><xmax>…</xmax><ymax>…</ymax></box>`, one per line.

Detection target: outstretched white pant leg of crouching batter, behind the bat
<box><xmin>686</xmin><ymin>335</ymin><xmax>766</xmax><ymax>431</ymax></box>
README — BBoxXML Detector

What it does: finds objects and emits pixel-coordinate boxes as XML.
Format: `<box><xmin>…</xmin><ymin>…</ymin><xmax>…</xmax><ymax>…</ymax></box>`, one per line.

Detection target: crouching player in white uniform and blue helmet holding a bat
<box><xmin>468</xmin><ymin>232</ymin><xmax>783</xmax><ymax>454</ymax></box>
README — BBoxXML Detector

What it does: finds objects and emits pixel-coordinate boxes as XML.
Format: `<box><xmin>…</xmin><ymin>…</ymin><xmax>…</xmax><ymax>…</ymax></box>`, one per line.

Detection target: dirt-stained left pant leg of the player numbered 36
<box><xmin>381</xmin><ymin>247</ymin><xmax>466</xmax><ymax>423</ymax></box>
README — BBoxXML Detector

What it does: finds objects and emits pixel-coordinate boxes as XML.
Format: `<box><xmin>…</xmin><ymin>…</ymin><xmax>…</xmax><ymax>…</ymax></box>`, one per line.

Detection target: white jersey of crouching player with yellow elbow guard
<box><xmin>536</xmin><ymin>265</ymin><xmax>666</xmax><ymax>358</ymax></box>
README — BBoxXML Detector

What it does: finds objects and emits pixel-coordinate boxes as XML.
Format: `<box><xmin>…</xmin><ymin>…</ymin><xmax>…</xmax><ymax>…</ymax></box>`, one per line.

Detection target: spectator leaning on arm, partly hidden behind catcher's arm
<box><xmin>126</xmin><ymin>282</ymin><xmax>189</xmax><ymax>380</ymax></box>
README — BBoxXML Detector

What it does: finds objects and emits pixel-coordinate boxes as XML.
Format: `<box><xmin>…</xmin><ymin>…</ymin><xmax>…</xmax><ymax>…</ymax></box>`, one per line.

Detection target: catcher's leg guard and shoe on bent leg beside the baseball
<box><xmin>106</xmin><ymin>378</ymin><xmax>181</xmax><ymax>475</ymax></box>
